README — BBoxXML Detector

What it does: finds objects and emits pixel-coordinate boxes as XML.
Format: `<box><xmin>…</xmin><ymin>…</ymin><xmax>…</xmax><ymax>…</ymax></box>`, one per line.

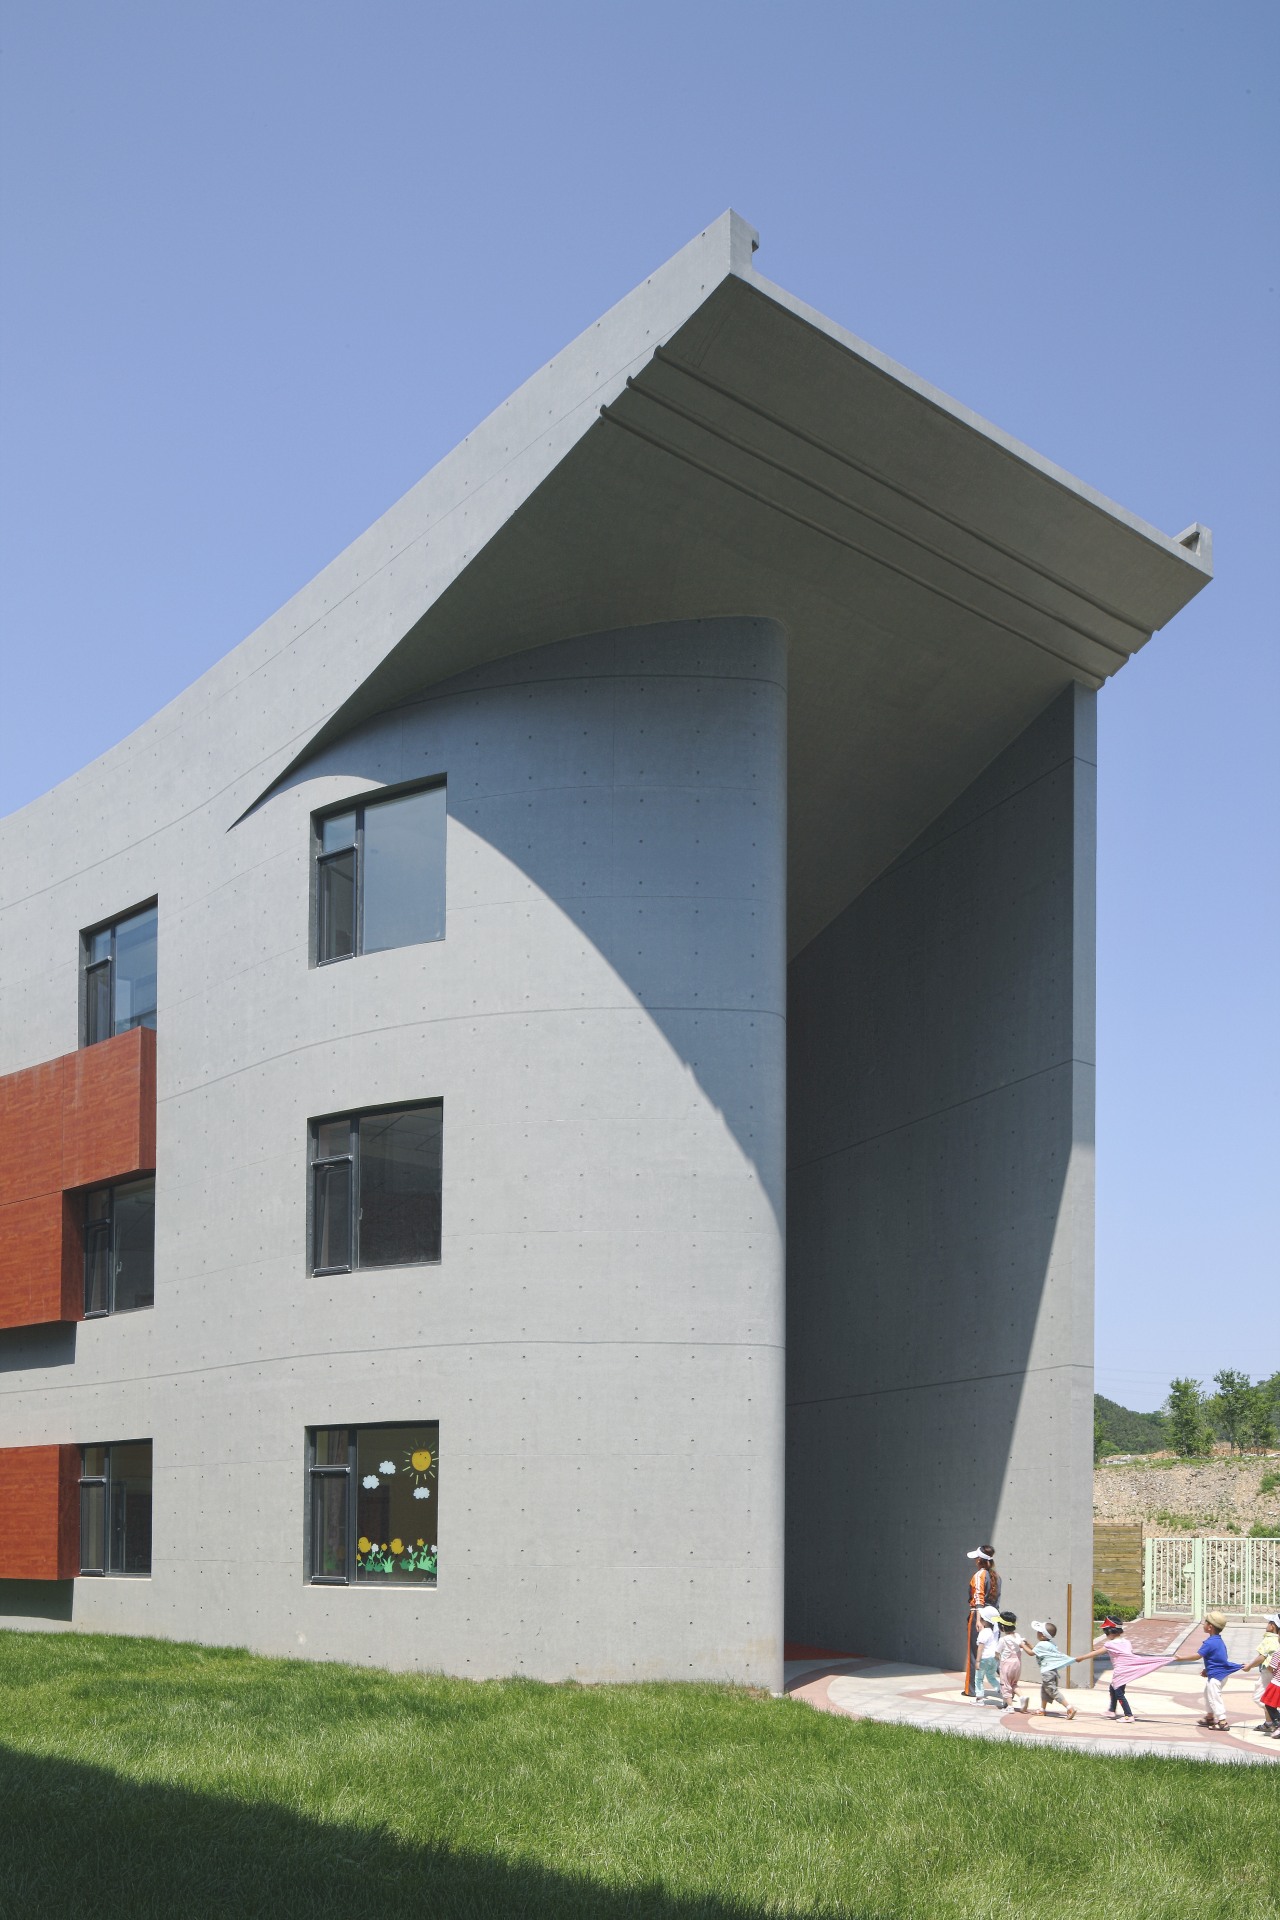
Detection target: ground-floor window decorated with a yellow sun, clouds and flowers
<box><xmin>307</xmin><ymin>1421</ymin><xmax>439</xmax><ymax>1586</ymax></box>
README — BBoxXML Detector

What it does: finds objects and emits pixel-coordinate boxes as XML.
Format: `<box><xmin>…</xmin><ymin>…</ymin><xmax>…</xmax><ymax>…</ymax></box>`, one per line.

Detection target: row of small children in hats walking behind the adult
<box><xmin>975</xmin><ymin>1605</ymin><xmax>1280</xmax><ymax>1740</ymax></box>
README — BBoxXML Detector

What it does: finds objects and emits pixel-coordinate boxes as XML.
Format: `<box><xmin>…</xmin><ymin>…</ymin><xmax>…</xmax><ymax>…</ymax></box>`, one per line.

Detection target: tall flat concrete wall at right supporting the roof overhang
<box><xmin>787</xmin><ymin>687</ymin><xmax>1096</xmax><ymax>1667</ymax></box>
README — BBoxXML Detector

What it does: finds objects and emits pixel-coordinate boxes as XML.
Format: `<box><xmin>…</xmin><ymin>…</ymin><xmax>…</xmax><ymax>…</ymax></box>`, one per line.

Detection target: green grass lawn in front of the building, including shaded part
<box><xmin>0</xmin><ymin>1634</ymin><xmax>1278</xmax><ymax>1920</ymax></box>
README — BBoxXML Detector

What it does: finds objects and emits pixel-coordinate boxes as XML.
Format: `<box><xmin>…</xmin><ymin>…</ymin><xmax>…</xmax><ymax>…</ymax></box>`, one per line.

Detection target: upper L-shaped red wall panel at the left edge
<box><xmin>0</xmin><ymin>1027</ymin><xmax>155</xmax><ymax>1327</ymax></box>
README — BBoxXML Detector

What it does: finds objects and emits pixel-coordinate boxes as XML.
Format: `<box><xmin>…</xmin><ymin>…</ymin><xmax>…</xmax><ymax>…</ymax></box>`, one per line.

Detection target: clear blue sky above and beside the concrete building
<box><xmin>0</xmin><ymin>0</ymin><xmax>1280</xmax><ymax>1407</ymax></box>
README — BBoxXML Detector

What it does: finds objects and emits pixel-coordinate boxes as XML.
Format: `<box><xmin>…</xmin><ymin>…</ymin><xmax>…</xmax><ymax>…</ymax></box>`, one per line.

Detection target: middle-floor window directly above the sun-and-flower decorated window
<box><xmin>309</xmin><ymin>1100</ymin><xmax>443</xmax><ymax>1273</ymax></box>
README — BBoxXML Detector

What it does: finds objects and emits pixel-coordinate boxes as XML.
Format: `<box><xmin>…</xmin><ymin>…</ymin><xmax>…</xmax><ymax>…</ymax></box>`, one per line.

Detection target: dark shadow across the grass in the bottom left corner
<box><xmin>0</xmin><ymin>1747</ymin><xmax>844</xmax><ymax>1920</ymax></box>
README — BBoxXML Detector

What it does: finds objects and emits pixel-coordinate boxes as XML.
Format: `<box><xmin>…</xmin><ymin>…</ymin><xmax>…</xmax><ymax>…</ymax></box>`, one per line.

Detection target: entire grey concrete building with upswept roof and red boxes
<box><xmin>0</xmin><ymin>213</ymin><xmax>1211</xmax><ymax>1686</ymax></box>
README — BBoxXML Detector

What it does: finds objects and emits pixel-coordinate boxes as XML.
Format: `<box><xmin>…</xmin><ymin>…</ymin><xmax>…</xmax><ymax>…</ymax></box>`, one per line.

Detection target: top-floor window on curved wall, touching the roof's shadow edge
<box><xmin>315</xmin><ymin>785</ymin><xmax>445</xmax><ymax>966</ymax></box>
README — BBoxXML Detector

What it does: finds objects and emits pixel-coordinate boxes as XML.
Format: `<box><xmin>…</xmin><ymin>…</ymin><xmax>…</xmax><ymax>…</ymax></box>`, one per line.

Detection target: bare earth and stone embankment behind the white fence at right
<box><xmin>1094</xmin><ymin>1455</ymin><xmax>1280</xmax><ymax>1534</ymax></box>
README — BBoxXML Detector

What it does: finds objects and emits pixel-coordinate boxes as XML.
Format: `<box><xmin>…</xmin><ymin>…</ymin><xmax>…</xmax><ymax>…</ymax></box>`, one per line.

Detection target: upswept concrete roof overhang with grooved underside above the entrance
<box><xmin>246</xmin><ymin>213</ymin><xmax>1211</xmax><ymax>950</ymax></box>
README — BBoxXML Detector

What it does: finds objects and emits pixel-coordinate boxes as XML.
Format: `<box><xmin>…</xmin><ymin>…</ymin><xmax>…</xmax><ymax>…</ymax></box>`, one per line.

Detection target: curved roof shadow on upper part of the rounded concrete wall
<box><xmin>274</xmin><ymin>618</ymin><xmax>787</xmax><ymax>1221</ymax></box>
